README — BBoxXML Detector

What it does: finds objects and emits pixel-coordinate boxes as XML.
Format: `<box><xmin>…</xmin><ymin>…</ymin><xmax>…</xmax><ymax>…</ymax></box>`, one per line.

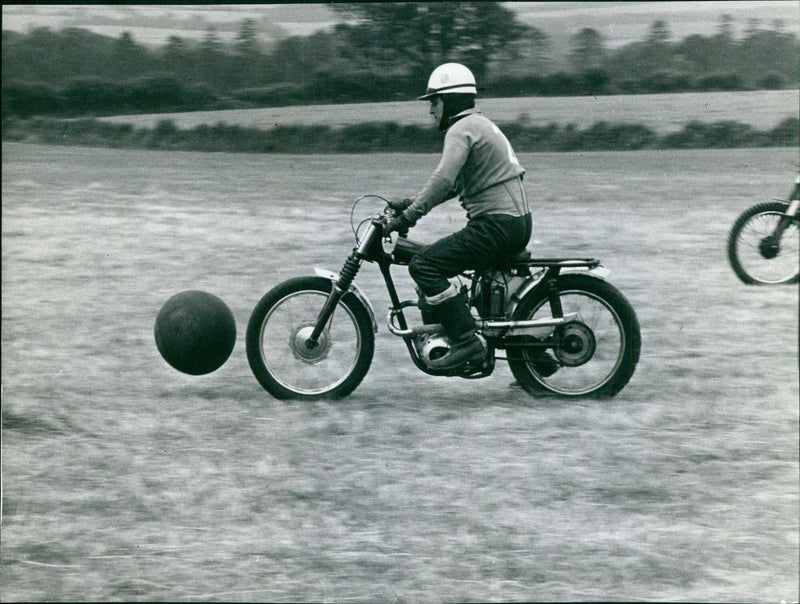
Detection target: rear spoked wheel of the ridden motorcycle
<box><xmin>508</xmin><ymin>275</ymin><xmax>641</xmax><ymax>398</ymax></box>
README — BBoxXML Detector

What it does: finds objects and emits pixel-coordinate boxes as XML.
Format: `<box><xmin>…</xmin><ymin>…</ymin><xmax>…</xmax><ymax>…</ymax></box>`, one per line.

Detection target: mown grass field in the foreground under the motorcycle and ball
<box><xmin>0</xmin><ymin>143</ymin><xmax>800</xmax><ymax>602</ymax></box>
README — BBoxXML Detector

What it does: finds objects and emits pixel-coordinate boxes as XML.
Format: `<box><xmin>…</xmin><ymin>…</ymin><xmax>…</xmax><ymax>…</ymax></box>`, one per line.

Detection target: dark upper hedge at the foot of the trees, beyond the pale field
<box><xmin>2</xmin><ymin>70</ymin><xmax>784</xmax><ymax>118</ymax></box>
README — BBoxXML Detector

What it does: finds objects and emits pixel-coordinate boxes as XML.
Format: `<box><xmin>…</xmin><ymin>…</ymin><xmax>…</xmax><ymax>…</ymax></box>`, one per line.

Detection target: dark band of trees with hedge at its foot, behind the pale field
<box><xmin>2</xmin><ymin>2</ymin><xmax>800</xmax><ymax>118</ymax></box>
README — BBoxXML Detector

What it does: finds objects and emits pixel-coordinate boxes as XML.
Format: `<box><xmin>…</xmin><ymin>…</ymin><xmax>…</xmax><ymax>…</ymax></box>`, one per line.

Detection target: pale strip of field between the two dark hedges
<box><xmin>98</xmin><ymin>90</ymin><xmax>800</xmax><ymax>134</ymax></box>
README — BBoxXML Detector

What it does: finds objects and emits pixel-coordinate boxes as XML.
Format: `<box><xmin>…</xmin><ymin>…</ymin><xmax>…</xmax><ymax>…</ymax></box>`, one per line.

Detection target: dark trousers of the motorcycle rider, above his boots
<box><xmin>408</xmin><ymin>214</ymin><xmax>532</xmax><ymax>297</ymax></box>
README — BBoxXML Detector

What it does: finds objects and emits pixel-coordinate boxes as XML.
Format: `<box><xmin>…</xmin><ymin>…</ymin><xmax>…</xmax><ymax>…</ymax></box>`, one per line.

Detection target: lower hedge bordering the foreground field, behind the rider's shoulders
<box><xmin>3</xmin><ymin>118</ymin><xmax>800</xmax><ymax>154</ymax></box>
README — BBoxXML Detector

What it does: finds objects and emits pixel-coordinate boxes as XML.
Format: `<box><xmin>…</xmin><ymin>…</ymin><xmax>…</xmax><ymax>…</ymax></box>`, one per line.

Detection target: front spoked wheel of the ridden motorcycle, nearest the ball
<box><xmin>247</xmin><ymin>277</ymin><xmax>375</xmax><ymax>400</ymax></box>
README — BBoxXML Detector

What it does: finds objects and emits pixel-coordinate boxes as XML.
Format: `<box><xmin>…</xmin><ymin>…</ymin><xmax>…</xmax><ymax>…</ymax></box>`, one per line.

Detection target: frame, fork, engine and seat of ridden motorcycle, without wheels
<box><xmin>307</xmin><ymin>217</ymin><xmax>603</xmax><ymax>378</ymax></box>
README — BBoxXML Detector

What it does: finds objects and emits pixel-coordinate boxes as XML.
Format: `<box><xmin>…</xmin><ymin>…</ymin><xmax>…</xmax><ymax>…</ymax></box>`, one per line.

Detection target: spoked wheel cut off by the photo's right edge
<box><xmin>728</xmin><ymin>202</ymin><xmax>800</xmax><ymax>285</ymax></box>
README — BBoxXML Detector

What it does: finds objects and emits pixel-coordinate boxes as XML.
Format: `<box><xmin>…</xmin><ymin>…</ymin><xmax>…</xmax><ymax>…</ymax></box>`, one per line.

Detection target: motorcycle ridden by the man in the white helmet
<box><xmin>246</xmin><ymin>195</ymin><xmax>641</xmax><ymax>400</ymax></box>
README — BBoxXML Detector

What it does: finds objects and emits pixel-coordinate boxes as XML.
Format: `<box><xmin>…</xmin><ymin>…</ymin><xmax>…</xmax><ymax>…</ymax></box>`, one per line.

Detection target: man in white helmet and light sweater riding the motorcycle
<box><xmin>386</xmin><ymin>63</ymin><xmax>532</xmax><ymax>369</ymax></box>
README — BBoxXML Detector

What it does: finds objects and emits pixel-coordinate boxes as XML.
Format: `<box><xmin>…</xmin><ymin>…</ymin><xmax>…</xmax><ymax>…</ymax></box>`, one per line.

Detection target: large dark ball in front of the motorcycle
<box><xmin>155</xmin><ymin>290</ymin><xmax>236</xmax><ymax>375</ymax></box>
